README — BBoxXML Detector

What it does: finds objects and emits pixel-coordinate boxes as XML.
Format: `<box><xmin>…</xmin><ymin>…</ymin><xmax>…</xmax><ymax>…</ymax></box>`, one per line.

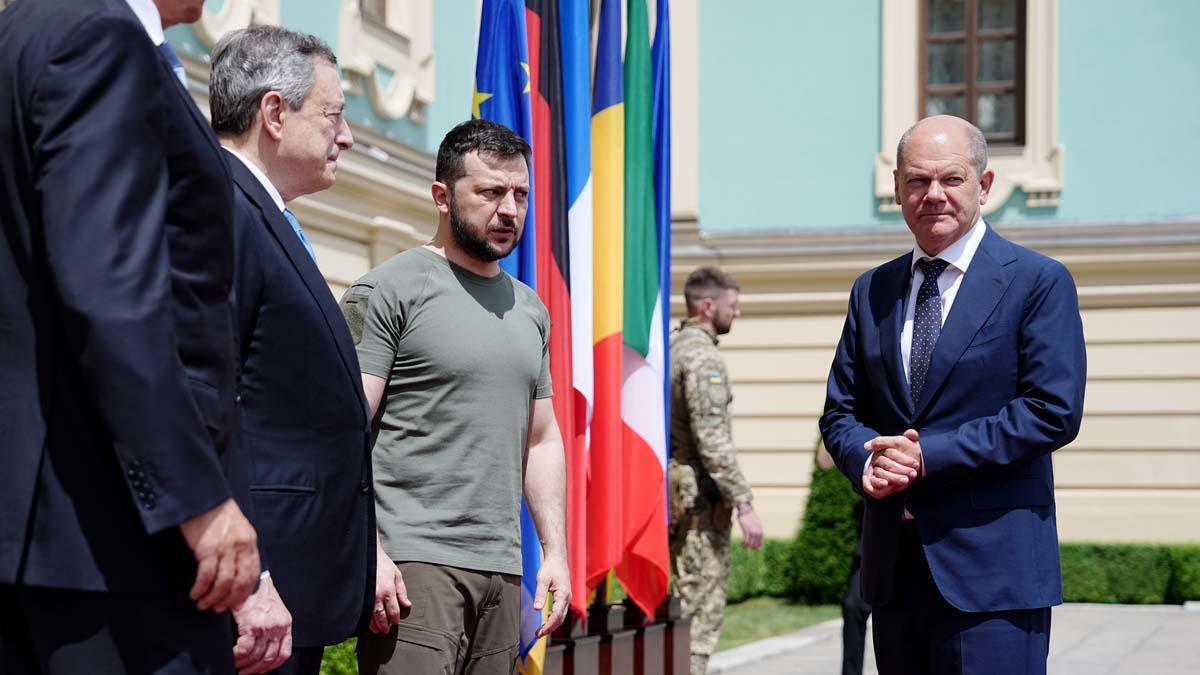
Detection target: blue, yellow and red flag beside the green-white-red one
<box><xmin>587</xmin><ymin>0</ymin><xmax>625</xmax><ymax>589</ymax></box>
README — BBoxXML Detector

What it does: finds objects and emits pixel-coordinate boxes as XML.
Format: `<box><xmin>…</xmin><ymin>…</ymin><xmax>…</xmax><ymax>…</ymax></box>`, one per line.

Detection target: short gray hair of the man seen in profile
<box><xmin>209</xmin><ymin>25</ymin><xmax>337</xmax><ymax>136</ymax></box>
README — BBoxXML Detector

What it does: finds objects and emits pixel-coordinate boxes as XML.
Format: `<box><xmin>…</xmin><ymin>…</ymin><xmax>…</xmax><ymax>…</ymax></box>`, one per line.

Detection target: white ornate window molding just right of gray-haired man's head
<box><xmin>337</xmin><ymin>0</ymin><xmax>434</xmax><ymax>123</ymax></box>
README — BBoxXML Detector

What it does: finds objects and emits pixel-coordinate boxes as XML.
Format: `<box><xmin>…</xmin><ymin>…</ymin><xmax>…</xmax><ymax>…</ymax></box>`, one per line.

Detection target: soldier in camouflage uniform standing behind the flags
<box><xmin>670</xmin><ymin>267</ymin><xmax>762</xmax><ymax>675</ymax></box>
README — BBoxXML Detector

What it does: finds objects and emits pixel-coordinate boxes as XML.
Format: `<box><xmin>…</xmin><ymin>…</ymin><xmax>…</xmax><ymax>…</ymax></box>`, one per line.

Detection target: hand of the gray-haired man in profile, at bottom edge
<box><xmin>233</xmin><ymin>577</ymin><xmax>292</xmax><ymax>675</ymax></box>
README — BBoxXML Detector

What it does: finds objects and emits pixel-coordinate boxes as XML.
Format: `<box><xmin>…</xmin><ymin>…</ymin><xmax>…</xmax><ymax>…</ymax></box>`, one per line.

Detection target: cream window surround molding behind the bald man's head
<box><xmin>875</xmin><ymin>0</ymin><xmax>1063</xmax><ymax>214</ymax></box>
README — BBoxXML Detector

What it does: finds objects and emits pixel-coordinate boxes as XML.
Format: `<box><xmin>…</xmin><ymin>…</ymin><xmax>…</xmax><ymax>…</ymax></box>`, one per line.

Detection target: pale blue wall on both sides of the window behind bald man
<box><xmin>698</xmin><ymin>0</ymin><xmax>1200</xmax><ymax>232</ymax></box>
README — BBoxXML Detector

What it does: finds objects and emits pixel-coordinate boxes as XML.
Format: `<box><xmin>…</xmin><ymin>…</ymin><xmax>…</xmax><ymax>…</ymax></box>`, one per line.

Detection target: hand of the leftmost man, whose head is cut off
<box><xmin>179</xmin><ymin>500</ymin><xmax>259</xmax><ymax>611</ymax></box>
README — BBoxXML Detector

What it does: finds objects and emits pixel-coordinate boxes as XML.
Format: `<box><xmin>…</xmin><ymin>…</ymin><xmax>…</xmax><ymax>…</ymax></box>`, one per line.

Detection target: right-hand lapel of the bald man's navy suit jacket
<box><xmin>916</xmin><ymin>227</ymin><xmax>1015</xmax><ymax>417</ymax></box>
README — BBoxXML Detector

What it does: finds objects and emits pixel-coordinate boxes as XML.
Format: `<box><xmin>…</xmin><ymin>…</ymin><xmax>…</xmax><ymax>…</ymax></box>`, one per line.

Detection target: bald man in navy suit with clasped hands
<box><xmin>821</xmin><ymin>117</ymin><xmax>1086</xmax><ymax>674</ymax></box>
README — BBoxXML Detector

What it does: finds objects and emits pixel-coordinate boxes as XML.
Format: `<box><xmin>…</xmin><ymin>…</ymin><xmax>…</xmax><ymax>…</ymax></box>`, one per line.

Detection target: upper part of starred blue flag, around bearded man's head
<box><xmin>470</xmin><ymin>0</ymin><xmax>538</xmax><ymax>283</ymax></box>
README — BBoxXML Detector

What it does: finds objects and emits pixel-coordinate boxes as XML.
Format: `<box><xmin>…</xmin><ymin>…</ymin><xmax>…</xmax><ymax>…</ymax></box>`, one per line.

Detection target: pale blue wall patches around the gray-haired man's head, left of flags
<box><xmin>167</xmin><ymin>0</ymin><xmax>479</xmax><ymax>153</ymax></box>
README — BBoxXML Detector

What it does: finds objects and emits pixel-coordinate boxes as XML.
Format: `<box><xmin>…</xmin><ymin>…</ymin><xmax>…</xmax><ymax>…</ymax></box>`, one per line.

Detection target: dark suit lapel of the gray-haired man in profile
<box><xmin>222</xmin><ymin>159</ymin><xmax>368</xmax><ymax>414</ymax></box>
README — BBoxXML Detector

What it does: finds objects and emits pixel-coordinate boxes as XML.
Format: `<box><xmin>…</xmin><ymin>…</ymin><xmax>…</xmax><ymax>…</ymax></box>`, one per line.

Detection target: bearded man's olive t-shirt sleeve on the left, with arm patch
<box><xmin>342</xmin><ymin>281</ymin><xmax>404</xmax><ymax>380</ymax></box>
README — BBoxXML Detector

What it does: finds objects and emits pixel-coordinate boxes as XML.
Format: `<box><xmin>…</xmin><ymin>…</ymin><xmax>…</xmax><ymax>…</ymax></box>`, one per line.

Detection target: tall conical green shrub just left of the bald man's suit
<box><xmin>788</xmin><ymin>444</ymin><xmax>862</xmax><ymax>604</ymax></box>
